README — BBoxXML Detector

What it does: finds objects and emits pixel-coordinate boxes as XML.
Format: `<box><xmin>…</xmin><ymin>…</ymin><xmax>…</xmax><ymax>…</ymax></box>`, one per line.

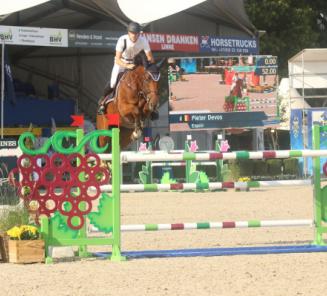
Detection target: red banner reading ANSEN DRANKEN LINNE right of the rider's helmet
<box><xmin>144</xmin><ymin>33</ymin><xmax>199</xmax><ymax>52</ymax></box>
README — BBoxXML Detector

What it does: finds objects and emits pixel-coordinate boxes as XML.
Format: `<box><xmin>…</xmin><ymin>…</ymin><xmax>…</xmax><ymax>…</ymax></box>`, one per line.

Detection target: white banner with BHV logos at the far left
<box><xmin>0</xmin><ymin>26</ymin><xmax>68</xmax><ymax>47</ymax></box>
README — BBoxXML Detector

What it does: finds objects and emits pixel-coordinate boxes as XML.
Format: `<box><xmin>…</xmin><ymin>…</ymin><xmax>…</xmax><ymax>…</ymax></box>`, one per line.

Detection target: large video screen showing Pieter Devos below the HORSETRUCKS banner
<box><xmin>168</xmin><ymin>56</ymin><xmax>278</xmax><ymax>131</ymax></box>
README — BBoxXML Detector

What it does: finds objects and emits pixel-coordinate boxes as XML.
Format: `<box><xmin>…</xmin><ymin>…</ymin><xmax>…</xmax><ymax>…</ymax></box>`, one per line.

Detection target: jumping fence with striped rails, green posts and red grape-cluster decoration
<box><xmin>12</xmin><ymin>125</ymin><xmax>327</xmax><ymax>263</ymax></box>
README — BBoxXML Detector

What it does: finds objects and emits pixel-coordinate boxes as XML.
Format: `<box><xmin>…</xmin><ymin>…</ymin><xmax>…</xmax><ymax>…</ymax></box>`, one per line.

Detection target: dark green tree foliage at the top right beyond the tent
<box><xmin>245</xmin><ymin>0</ymin><xmax>327</xmax><ymax>77</ymax></box>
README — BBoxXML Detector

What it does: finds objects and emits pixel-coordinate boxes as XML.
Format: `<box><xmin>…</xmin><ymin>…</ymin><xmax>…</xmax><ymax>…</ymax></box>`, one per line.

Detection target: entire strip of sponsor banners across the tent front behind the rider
<box><xmin>0</xmin><ymin>26</ymin><xmax>259</xmax><ymax>55</ymax></box>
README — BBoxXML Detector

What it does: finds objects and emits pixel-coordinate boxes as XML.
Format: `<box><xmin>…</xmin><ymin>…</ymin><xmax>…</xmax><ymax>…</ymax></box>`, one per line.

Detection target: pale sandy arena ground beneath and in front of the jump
<box><xmin>0</xmin><ymin>187</ymin><xmax>327</xmax><ymax>296</ymax></box>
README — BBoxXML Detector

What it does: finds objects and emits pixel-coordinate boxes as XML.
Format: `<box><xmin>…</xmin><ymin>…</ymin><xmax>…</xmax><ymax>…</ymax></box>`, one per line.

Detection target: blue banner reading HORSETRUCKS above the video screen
<box><xmin>200</xmin><ymin>36</ymin><xmax>259</xmax><ymax>55</ymax></box>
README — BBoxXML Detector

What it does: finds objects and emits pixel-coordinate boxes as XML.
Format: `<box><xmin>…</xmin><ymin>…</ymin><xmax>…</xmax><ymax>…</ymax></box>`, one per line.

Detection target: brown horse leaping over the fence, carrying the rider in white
<box><xmin>96</xmin><ymin>52</ymin><xmax>164</xmax><ymax>149</ymax></box>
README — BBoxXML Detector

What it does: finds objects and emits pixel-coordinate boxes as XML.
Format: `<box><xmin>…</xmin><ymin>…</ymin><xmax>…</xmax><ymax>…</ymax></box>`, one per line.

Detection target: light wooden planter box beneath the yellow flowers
<box><xmin>8</xmin><ymin>240</ymin><xmax>44</xmax><ymax>263</ymax></box>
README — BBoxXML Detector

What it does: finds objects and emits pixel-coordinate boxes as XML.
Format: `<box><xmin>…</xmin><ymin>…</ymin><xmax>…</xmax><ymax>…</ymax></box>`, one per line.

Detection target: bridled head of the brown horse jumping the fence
<box><xmin>141</xmin><ymin>60</ymin><xmax>164</xmax><ymax>112</ymax></box>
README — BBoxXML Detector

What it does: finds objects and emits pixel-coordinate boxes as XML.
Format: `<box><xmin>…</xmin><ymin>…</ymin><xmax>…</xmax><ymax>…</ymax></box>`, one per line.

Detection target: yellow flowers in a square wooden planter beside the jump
<box><xmin>7</xmin><ymin>225</ymin><xmax>44</xmax><ymax>263</ymax></box>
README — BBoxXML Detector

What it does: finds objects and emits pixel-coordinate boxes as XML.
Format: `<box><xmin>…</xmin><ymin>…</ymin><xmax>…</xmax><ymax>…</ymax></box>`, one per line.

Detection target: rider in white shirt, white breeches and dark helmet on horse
<box><xmin>99</xmin><ymin>22</ymin><xmax>158</xmax><ymax>118</ymax></box>
